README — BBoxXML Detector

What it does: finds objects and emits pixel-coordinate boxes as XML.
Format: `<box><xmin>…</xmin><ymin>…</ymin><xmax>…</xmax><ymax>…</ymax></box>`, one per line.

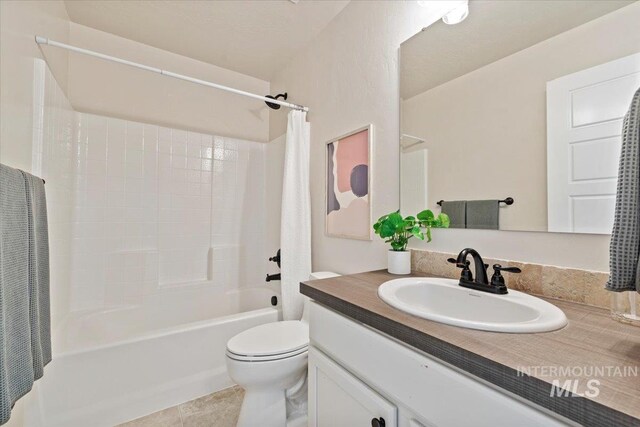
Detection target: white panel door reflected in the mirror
<box><xmin>547</xmin><ymin>53</ymin><xmax>640</xmax><ymax>234</ymax></box>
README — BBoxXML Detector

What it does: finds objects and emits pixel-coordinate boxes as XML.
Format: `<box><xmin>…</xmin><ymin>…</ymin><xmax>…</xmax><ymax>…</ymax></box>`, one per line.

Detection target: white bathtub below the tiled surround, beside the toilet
<box><xmin>25</xmin><ymin>286</ymin><xmax>280</xmax><ymax>427</ymax></box>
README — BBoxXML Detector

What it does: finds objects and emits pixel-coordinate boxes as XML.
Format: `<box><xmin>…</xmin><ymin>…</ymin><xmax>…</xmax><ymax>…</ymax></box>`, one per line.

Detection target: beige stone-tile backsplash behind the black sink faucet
<box><xmin>411</xmin><ymin>249</ymin><xmax>611</xmax><ymax>308</ymax></box>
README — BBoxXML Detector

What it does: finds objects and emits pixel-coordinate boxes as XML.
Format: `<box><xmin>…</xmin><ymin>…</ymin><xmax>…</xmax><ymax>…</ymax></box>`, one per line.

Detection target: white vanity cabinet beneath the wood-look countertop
<box><xmin>309</xmin><ymin>302</ymin><xmax>572</xmax><ymax>427</ymax></box>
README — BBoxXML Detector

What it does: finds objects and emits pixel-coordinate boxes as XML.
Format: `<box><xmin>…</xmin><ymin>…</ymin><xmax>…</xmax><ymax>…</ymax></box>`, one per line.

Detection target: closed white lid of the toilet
<box><xmin>227</xmin><ymin>320</ymin><xmax>309</xmax><ymax>356</ymax></box>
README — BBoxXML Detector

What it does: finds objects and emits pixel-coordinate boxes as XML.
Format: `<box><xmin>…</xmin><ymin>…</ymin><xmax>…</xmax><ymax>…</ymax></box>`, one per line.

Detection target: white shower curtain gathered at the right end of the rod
<box><xmin>280</xmin><ymin>110</ymin><xmax>311</xmax><ymax>320</ymax></box>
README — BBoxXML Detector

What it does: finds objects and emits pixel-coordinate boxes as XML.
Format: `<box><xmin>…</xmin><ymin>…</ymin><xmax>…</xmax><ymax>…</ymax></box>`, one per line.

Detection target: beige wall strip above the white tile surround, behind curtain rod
<box><xmin>66</xmin><ymin>23</ymin><xmax>269</xmax><ymax>142</ymax></box>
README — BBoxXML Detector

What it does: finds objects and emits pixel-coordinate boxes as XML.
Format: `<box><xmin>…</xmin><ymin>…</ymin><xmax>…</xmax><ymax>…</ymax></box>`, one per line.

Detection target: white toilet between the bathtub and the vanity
<box><xmin>227</xmin><ymin>271</ymin><xmax>339</xmax><ymax>427</ymax></box>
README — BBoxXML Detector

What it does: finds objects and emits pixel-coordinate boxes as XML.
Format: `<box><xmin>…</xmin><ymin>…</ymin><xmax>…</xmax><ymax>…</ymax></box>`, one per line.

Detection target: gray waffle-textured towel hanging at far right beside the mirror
<box><xmin>606</xmin><ymin>88</ymin><xmax>640</xmax><ymax>292</ymax></box>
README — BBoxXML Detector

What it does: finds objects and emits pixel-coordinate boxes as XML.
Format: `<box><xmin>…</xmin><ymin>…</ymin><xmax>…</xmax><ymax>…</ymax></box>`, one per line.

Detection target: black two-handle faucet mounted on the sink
<box><xmin>447</xmin><ymin>248</ymin><xmax>521</xmax><ymax>295</ymax></box>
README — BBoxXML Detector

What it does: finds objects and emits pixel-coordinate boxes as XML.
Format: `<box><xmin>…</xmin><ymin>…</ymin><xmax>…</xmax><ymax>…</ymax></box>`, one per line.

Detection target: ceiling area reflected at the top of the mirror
<box><xmin>400</xmin><ymin>0</ymin><xmax>633</xmax><ymax>99</ymax></box>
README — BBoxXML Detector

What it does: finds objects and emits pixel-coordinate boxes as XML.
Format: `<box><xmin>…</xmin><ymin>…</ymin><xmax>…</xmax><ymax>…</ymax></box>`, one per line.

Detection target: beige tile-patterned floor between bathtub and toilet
<box><xmin>120</xmin><ymin>386</ymin><xmax>244</xmax><ymax>427</ymax></box>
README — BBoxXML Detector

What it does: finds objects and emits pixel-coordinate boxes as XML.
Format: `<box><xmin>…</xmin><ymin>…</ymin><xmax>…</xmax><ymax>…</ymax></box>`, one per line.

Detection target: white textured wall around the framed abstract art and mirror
<box><xmin>270</xmin><ymin>1</ymin><xmax>609</xmax><ymax>273</ymax></box>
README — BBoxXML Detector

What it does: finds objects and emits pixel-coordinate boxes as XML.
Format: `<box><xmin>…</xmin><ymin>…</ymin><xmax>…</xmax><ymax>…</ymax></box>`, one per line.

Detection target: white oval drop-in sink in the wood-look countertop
<box><xmin>378</xmin><ymin>277</ymin><xmax>567</xmax><ymax>333</ymax></box>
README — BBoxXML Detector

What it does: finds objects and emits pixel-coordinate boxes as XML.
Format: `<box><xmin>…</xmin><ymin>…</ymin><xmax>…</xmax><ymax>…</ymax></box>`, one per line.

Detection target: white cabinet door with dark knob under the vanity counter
<box><xmin>309</xmin><ymin>348</ymin><xmax>398</xmax><ymax>427</ymax></box>
